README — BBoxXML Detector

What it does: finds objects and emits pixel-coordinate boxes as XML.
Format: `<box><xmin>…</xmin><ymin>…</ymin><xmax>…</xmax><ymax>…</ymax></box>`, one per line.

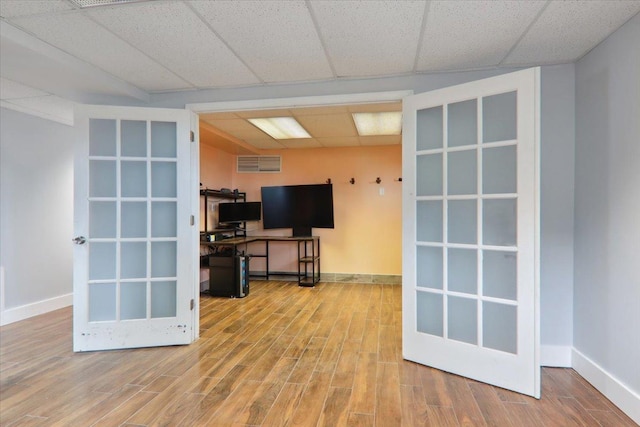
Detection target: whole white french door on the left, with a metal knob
<box><xmin>73</xmin><ymin>105</ymin><xmax>198</xmax><ymax>351</ymax></box>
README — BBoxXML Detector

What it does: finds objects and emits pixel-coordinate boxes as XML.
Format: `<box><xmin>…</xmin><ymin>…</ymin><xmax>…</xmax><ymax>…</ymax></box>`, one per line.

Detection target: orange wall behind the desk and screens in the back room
<box><xmin>228</xmin><ymin>145</ymin><xmax>402</xmax><ymax>275</ymax></box>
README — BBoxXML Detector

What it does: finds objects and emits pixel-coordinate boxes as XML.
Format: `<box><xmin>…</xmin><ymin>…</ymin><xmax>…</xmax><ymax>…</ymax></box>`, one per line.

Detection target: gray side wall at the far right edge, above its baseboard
<box><xmin>574</xmin><ymin>15</ymin><xmax>640</xmax><ymax>393</ymax></box>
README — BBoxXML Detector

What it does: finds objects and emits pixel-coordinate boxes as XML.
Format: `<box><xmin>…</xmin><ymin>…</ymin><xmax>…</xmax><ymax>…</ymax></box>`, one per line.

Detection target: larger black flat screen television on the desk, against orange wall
<box><xmin>261</xmin><ymin>184</ymin><xmax>334</xmax><ymax>237</ymax></box>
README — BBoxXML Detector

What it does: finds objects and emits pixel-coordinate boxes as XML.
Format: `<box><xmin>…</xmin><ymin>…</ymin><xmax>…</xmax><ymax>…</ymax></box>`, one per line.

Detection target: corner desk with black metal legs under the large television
<box><xmin>200</xmin><ymin>236</ymin><xmax>320</xmax><ymax>287</ymax></box>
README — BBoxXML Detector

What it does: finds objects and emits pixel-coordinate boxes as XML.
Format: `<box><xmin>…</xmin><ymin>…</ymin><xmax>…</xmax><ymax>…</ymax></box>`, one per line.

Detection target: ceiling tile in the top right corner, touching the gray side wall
<box><xmin>501</xmin><ymin>0</ymin><xmax>640</xmax><ymax>65</ymax></box>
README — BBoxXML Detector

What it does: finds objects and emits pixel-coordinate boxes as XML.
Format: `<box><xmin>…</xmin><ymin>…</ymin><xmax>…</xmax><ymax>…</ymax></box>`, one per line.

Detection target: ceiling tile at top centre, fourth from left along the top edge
<box><xmin>310</xmin><ymin>0</ymin><xmax>428</xmax><ymax>77</ymax></box>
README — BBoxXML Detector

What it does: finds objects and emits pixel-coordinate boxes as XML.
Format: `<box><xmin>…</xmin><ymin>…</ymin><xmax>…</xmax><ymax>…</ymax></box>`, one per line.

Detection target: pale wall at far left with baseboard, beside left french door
<box><xmin>0</xmin><ymin>108</ymin><xmax>73</xmax><ymax>324</ymax></box>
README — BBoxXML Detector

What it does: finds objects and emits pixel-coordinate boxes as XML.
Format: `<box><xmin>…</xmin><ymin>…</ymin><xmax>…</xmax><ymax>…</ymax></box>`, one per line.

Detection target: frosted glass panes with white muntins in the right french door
<box><xmin>416</xmin><ymin>91</ymin><xmax>518</xmax><ymax>354</ymax></box>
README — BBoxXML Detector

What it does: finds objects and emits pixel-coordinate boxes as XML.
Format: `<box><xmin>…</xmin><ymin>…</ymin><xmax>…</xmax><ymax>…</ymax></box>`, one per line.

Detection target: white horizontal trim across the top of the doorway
<box><xmin>185</xmin><ymin>90</ymin><xmax>413</xmax><ymax>113</ymax></box>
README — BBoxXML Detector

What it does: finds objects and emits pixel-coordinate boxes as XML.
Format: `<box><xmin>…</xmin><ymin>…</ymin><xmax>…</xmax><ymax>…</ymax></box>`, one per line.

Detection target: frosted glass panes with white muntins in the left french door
<box><xmin>87</xmin><ymin>119</ymin><xmax>178</xmax><ymax>322</ymax></box>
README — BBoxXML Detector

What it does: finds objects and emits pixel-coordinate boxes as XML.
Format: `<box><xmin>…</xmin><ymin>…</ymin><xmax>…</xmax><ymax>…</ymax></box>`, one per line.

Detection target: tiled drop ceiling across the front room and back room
<box><xmin>0</xmin><ymin>0</ymin><xmax>640</xmax><ymax>148</ymax></box>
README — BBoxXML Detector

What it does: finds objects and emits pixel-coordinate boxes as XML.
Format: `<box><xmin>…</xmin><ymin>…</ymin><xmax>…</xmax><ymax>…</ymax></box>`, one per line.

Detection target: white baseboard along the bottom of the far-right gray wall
<box><xmin>572</xmin><ymin>348</ymin><xmax>640</xmax><ymax>424</ymax></box>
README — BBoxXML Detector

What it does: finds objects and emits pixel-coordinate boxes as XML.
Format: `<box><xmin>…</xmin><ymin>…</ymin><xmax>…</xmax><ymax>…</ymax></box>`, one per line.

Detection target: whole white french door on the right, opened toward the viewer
<box><xmin>403</xmin><ymin>69</ymin><xmax>540</xmax><ymax>397</ymax></box>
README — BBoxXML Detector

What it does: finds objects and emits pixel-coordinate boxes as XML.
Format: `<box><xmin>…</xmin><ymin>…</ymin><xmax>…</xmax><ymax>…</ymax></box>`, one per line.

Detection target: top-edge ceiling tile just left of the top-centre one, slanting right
<box><xmin>190</xmin><ymin>0</ymin><xmax>333</xmax><ymax>83</ymax></box>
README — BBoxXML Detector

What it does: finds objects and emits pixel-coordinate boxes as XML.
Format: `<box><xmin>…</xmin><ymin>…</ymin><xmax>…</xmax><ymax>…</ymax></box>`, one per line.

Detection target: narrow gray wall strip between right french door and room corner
<box><xmin>540</xmin><ymin>65</ymin><xmax>575</xmax><ymax>350</ymax></box>
